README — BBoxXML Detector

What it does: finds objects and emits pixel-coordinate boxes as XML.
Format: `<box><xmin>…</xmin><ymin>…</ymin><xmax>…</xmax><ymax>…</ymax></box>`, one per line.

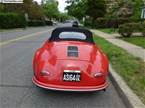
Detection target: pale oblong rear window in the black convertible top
<box><xmin>59</xmin><ymin>32</ymin><xmax>86</xmax><ymax>40</ymax></box>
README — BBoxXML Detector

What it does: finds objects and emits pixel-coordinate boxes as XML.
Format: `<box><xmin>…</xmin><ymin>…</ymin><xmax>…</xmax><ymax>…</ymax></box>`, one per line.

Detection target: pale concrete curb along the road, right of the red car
<box><xmin>109</xmin><ymin>65</ymin><xmax>145</xmax><ymax>108</ymax></box>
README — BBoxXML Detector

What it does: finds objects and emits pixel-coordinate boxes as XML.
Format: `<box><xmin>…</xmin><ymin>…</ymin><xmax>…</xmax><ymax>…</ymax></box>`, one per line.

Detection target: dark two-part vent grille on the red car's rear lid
<box><xmin>67</xmin><ymin>46</ymin><xmax>78</xmax><ymax>57</ymax></box>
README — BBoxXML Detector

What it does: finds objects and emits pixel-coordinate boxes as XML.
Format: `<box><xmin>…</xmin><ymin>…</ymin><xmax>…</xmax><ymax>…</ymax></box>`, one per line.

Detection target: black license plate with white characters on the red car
<box><xmin>63</xmin><ymin>70</ymin><xmax>81</xmax><ymax>82</ymax></box>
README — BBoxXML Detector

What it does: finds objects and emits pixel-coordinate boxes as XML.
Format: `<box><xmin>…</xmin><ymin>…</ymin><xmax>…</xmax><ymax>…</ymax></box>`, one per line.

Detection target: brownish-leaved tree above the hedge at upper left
<box><xmin>0</xmin><ymin>0</ymin><xmax>44</xmax><ymax>20</ymax></box>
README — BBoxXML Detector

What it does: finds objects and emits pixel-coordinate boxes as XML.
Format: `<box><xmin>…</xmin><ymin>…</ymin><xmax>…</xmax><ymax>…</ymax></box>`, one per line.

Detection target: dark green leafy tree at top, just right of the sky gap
<box><xmin>66</xmin><ymin>0</ymin><xmax>106</xmax><ymax>26</ymax></box>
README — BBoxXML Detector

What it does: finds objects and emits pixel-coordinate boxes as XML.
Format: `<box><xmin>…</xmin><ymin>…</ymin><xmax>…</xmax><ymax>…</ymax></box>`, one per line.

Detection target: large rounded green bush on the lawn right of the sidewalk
<box><xmin>118</xmin><ymin>23</ymin><xmax>143</xmax><ymax>37</ymax></box>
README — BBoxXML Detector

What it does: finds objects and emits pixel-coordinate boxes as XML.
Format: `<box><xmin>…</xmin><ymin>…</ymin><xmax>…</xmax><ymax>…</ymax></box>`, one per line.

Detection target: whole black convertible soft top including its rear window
<box><xmin>49</xmin><ymin>27</ymin><xmax>94</xmax><ymax>43</ymax></box>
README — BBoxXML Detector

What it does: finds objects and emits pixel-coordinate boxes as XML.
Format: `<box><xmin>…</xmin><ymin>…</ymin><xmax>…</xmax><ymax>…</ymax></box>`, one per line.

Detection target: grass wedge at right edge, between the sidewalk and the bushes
<box><xmin>121</xmin><ymin>36</ymin><xmax>145</xmax><ymax>48</ymax></box>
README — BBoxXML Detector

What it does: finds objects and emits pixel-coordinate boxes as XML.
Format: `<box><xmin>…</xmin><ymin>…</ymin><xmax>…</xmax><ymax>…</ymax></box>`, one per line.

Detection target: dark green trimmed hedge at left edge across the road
<box><xmin>0</xmin><ymin>13</ymin><xmax>27</xmax><ymax>29</ymax></box>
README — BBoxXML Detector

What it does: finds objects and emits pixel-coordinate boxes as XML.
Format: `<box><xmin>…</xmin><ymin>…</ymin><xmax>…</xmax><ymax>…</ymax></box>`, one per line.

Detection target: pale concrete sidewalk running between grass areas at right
<box><xmin>92</xmin><ymin>30</ymin><xmax>145</xmax><ymax>61</ymax></box>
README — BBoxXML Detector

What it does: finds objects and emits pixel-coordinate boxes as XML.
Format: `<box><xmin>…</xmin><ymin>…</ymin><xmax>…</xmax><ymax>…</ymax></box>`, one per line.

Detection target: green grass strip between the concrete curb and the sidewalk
<box><xmin>94</xmin><ymin>36</ymin><xmax>145</xmax><ymax>103</ymax></box>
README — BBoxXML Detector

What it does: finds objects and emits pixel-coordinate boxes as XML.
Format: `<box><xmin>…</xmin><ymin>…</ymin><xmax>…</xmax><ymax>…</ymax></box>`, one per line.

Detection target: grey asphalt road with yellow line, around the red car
<box><xmin>0</xmin><ymin>24</ymin><xmax>126</xmax><ymax>108</ymax></box>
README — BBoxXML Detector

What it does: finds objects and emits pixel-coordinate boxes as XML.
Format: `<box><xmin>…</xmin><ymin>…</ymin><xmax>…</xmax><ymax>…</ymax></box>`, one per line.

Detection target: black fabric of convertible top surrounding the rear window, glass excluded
<box><xmin>49</xmin><ymin>27</ymin><xmax>94</xmax><ymax>43</ymax></box>
